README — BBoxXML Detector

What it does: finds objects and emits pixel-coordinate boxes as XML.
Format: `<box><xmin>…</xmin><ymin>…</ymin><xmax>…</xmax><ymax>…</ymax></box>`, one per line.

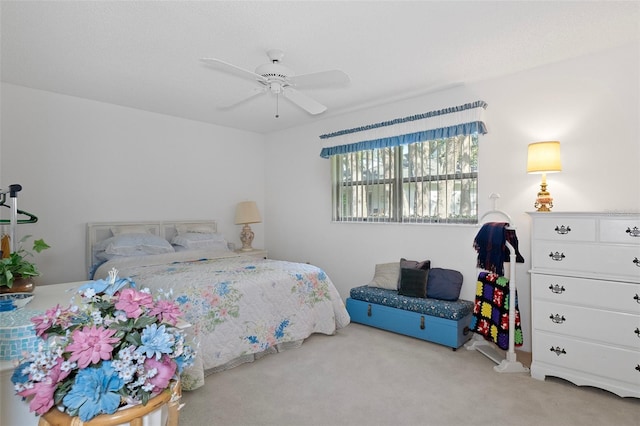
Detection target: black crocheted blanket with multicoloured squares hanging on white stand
<box><xmin>469</xmin><ymin>271</ymin><xmax>523</xmax><ymax>350</ymax></box>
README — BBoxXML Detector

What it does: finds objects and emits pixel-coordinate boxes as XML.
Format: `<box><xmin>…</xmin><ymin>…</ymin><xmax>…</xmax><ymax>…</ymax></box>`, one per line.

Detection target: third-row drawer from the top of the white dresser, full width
<box><xmin>531</xmin><ymin>274</ymin><xmax>640</xmax><ymax>315</ymax></box>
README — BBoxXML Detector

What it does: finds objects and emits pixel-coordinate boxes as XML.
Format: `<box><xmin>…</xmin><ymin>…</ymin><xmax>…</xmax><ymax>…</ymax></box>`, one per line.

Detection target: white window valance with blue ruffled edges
<box><xmin>320</xmin><ymin>101</ymin><xmax>487</xmax><ymax>158</ymax></box>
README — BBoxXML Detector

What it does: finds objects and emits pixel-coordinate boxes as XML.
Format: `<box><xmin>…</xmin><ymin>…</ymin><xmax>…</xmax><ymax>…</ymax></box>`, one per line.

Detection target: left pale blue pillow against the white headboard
<box><xmin>94</xmin><ymin>233</ymin><xmax>175</xmax><ymax>258</ymax></box>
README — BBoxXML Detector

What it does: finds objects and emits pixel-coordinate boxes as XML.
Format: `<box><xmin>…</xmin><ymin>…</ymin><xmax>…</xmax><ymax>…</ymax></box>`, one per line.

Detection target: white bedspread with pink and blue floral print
<box><xmin>96</xmin><ymin>252</ymin><xmax>350</xmax><ymax>390</ymax></box>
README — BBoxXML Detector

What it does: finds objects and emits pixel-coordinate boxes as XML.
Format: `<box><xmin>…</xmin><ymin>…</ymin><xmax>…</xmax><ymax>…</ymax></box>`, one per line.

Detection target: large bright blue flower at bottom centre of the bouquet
<box><xmin>62</xmin><ymin>361</ymin><xmax>124</xmax><ymax>422</ymax></box>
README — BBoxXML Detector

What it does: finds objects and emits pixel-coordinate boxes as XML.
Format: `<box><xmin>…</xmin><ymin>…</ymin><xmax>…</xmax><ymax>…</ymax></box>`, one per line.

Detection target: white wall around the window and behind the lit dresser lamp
<box><xmin>265</xmin><ymin>44</ymin><xmax>640</xmax><ymax>350</ymax></box>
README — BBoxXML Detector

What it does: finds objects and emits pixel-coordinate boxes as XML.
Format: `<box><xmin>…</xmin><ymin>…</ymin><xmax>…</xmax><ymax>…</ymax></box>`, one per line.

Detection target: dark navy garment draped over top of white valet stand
<box><xmin>473</xmin><ymin>222</ymin><xmax>524</xmax><ymax>275</ymax></box>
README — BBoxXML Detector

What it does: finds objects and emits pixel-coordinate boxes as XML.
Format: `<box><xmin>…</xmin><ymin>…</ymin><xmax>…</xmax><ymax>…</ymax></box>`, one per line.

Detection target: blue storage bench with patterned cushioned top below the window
<box><xmin>347</xmin><ymin>285</ymin><xmax>473</xmax><ymax>350</ymax></box>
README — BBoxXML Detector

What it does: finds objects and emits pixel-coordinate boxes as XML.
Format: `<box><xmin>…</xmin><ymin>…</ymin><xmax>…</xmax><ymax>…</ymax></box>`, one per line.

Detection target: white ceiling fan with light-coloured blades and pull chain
<box><xmin>201</xmin><ymin>49</ymin><xmax>350</xmax><ymax>118</ymax></box>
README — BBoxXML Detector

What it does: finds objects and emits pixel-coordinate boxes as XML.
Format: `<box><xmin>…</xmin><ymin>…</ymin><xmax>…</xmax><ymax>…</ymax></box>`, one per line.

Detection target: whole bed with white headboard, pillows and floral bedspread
<box><xmin>86</xmin><ymin>221</ymin><xmax>350</xmax><ymax>390</ymax></box>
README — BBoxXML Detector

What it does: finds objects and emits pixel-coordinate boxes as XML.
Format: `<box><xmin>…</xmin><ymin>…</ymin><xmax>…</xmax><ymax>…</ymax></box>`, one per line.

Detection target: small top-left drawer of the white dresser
<box><xmin>533</xmin><ymin>217</ymin><xmax>596</xmax><ymax>241</ymax></box>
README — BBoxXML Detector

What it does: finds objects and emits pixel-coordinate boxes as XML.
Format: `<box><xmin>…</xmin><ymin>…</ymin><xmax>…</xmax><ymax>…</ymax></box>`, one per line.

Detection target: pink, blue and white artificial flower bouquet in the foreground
<box><xmin>12</xmin><ymin>269</ymin><xmax>195</xmax><ymax>422</ymax></box>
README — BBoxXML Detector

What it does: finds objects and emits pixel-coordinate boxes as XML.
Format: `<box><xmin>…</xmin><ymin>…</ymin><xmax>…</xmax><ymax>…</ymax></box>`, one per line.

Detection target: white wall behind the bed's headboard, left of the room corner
<box><xmin>0</xmin><ymin>84</ymin><xmax>265</xmax><ymax>284</ymax></box>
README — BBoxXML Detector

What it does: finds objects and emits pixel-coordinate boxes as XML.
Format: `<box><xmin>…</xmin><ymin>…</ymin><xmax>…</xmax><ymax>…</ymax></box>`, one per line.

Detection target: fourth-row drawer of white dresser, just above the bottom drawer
<box><xmin>532</xmin><ymin>301</ymin><xmax>640</xmax><ymax>351</ymax></box>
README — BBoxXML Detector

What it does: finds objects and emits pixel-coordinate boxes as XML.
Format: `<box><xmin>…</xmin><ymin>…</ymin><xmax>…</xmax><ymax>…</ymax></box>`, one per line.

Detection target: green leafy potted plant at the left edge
<box><xmin>0</xmin><ymin>235</ymin><xmax>49</xmax><ymax>293</ymax></box>
